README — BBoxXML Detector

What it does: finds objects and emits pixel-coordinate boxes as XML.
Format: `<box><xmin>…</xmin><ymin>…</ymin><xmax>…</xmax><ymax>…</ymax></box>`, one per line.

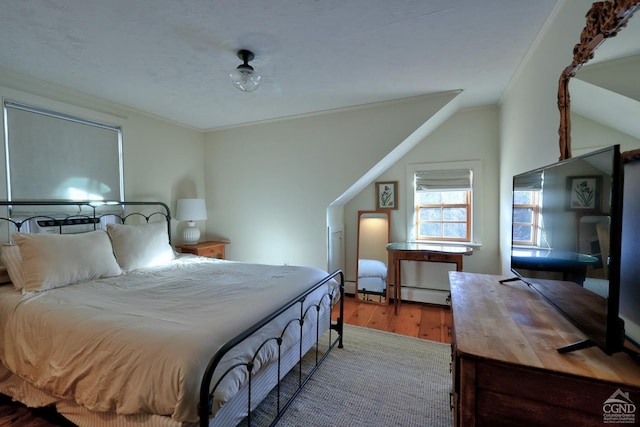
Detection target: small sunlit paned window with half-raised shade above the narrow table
<box><xmin>413</xmin><ymin>169</ymin><xmax>473</xmax><ymax>242</ymax></box>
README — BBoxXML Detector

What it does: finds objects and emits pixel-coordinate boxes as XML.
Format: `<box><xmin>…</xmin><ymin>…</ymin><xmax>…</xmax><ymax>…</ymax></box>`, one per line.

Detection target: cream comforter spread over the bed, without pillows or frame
<box><xmin>0</xmin><ymin>257</ymin><xmax>335</xmax><ymax>422</ymax></box>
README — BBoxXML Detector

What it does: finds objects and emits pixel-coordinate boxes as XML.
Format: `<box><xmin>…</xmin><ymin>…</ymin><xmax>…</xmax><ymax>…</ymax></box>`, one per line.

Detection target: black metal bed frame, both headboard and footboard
<box><xmin>0</xmin><ymin>201</ymin><xmax>344</xmax><ymax>427</ymax></box>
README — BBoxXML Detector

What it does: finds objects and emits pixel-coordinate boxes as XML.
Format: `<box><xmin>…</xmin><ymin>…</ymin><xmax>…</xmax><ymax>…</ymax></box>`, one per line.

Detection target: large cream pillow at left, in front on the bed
<box><xmin>13</xmin><ymin>230</ymin><xmax>122</xmax><ymax>291</ymax></box>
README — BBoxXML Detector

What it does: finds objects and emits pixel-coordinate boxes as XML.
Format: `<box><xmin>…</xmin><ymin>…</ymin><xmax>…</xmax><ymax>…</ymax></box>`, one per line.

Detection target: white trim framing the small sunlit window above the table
<box><xmin>405</xmin><ymin>160</ymin><xmax>483</xmax><ymax>246</ymax></box>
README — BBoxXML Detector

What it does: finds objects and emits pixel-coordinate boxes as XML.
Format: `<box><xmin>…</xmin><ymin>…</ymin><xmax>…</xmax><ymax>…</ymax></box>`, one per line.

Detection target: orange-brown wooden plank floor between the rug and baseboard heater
<box><xmin>334</xmin><ymin>295</ymin><xmax>453</xmax><ymax>344</ymax></box>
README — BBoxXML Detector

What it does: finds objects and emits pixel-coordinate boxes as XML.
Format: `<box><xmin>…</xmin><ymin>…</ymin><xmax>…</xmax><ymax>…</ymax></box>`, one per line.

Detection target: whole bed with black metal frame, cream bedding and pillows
<box><xmin>0</xmin><ymin>202</ymin><xmax>344</xmax><ymax>426</ymax></box>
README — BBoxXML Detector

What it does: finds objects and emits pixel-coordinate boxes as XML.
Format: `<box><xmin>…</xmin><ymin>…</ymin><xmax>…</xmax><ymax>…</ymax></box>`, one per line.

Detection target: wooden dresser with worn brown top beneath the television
<box><xmin>449</xmin><ymin>271</ymin><xmax>640</xmax><ymax>427</ymax></box>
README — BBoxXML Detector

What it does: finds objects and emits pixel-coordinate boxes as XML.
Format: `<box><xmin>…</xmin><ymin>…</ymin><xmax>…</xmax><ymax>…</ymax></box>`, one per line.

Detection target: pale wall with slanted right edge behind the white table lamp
<box><xmin>205</xmin><ymin>94</ymin><xmax>458</xmax><ymax>268</ymax></box>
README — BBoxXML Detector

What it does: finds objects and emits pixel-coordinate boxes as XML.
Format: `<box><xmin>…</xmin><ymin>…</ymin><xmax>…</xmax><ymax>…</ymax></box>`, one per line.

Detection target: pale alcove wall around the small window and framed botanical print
<box><xmin>344</xmin><ymin>106</ymin><xmax>500</xmax><ymax>280</ymax></box>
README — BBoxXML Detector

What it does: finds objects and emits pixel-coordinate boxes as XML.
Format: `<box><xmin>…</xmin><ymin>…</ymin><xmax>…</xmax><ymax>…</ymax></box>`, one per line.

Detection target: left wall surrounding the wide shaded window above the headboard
<box><xmin>0</xmin><ymin>74</ymin><xmax>204</xmax><ymax>242</ymax></box>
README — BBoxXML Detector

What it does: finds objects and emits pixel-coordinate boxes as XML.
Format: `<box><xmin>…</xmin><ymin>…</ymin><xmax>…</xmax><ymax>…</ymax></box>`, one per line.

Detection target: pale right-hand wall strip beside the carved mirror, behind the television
<box><xmin>500</xmin><ymin>0</ymin><xmax>592</xmax><ymax>274</ymax></box>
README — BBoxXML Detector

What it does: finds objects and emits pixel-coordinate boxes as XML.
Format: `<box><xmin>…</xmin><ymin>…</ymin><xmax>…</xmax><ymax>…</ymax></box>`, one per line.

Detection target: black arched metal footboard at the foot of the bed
<box><xmin>198</xmin><ymin>270</ymin><xmax>344</xmax><ymax>427</ymax></box>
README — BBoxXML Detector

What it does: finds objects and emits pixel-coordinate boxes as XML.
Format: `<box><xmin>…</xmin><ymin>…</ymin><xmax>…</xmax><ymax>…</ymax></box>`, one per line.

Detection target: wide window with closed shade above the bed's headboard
<box><xmin>4</xmin><ymin>100</ymin><xmax>124</xmax><ymax>200</ymax></box>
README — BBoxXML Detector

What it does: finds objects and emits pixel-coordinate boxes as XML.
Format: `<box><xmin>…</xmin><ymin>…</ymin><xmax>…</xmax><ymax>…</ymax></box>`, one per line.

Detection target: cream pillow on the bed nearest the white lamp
<box><xmin>107</xmin><ymin>222</ymin><xmax>176</xmax><ymax>270</ymax></box>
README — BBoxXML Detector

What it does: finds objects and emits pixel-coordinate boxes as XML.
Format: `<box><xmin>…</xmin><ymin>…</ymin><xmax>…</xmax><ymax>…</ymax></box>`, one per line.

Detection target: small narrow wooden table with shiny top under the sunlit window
<box><xmin>387</xmin><ymin>242</ymin><xmax>473</xmax><ymax>314</ymax></box>
